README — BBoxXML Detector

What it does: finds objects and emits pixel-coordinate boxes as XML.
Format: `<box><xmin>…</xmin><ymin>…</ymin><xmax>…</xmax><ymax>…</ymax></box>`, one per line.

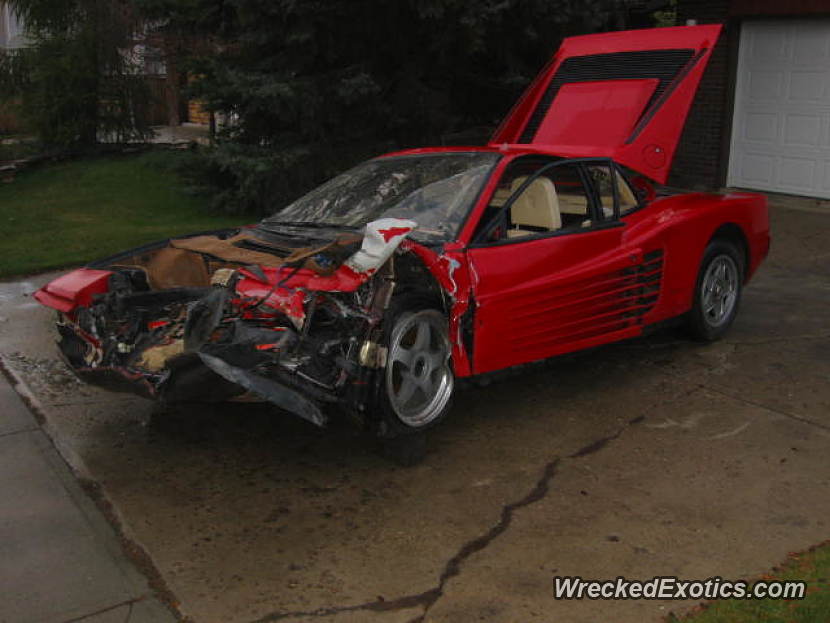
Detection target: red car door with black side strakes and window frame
<box><xmin>467</xmin><ymin>160</ymin><xmax>662</xmax><ymax>374</ymax></box>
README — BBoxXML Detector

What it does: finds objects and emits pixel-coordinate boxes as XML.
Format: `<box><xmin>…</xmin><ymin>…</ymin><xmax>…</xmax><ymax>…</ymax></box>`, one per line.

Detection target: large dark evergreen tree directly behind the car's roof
<box><xmin>185</xmin><ymin>0</ymin><xmax>625</xmax><ymax>213</ymax></box>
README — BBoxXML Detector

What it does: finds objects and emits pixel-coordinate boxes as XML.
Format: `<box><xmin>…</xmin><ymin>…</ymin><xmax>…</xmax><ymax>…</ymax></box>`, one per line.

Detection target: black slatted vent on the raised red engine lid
<box><xmin>519</xmin><ymin>49</ymin><xmax>700</xmax><ymax>143</ymax></box>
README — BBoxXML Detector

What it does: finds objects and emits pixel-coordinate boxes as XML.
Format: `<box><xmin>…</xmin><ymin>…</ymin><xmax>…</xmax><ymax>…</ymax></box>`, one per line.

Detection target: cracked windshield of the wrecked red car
<box><xmin>263</xmin><ymin>152</ymin><xmax>499</xmax><ymax>243</ymax></box>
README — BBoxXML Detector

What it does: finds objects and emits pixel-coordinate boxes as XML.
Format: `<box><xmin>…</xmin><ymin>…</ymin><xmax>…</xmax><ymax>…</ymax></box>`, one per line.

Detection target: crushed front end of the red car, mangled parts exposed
<box><xmin>35</xmin><ymin>219</ymin><xmax>433</xmax><ymax>425</ymax></box>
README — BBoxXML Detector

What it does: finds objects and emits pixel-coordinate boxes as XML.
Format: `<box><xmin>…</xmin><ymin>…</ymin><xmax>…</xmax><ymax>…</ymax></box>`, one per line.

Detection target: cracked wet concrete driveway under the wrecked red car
<box><xmin>0</xmin><ymin>203</ymin><xmax>830</xmax><ymax>623</ymax></box>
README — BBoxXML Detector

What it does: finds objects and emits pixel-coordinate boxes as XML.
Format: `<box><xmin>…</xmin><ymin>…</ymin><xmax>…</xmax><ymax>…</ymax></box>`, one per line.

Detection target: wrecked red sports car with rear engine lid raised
<box><xmin>36</xmin><ymin>26</ymin><xmax>769</xmax><ymax>454</ymax></box>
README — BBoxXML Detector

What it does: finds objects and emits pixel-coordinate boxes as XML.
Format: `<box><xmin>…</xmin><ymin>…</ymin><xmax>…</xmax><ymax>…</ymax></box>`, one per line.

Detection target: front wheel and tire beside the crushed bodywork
<box><xmin>376</xmin><ymin>296</ymin><xmax>455</xmax><ymax>440</ymax></box>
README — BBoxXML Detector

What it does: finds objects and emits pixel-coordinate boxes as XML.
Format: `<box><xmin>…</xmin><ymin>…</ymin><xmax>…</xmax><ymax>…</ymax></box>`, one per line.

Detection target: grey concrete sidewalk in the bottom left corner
<box><xmin>0</xmin><ymin>373</ymin><xmax>175</xmax><ymax>623</ymax></box>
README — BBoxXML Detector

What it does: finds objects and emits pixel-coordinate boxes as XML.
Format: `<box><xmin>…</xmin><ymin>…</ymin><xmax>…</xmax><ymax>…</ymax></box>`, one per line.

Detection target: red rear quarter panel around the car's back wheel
<box><xmin>623</xmin><ymin>193</ymin><xmax>770</xmax><ymax>323</ymax></box>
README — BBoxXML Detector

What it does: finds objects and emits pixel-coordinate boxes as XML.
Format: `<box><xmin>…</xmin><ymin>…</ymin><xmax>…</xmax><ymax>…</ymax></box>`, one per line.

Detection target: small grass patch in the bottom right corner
<box><xmin>667</xmin><ymin>541</ymin><xmax>830</xmax><ymax>623</ymax></box>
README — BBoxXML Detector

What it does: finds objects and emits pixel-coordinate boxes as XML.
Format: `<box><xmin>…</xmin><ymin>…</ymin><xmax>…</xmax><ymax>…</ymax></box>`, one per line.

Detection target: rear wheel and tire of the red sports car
<box><xmin>688</xmin><ymin>238</ymin><xmax>744</xmax><ymax>342</ymax></box>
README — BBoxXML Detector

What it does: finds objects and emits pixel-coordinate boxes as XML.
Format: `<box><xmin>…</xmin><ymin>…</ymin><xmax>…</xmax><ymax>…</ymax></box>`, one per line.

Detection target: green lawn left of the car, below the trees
<box><xmin>0</xmin><ymin>151</ymin><xmax>245</xmax><ymax>277</ymax></box>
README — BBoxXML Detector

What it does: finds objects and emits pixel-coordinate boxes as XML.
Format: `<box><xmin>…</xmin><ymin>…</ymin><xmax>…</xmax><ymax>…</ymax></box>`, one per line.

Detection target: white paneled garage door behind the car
<box><xmin>727</xmin><ymin>19</ymin><xmax>830</xmax><ymax>199</ymax></box>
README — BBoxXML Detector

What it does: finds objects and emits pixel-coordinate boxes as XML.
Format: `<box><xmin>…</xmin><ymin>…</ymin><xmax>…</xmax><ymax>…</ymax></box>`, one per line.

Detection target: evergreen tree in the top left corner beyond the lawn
<box><xmin>0</xmin><ymin>0</ymin><xmax>152</xmax><ymax>147</ymax></box>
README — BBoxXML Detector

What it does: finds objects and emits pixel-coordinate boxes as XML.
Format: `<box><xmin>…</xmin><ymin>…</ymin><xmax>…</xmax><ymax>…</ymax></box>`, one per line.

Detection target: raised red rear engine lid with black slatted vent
<box><xmin>491</xmin><ymin>25</ymin><xmax>721</xmax><ymax>183</ymax></box>
